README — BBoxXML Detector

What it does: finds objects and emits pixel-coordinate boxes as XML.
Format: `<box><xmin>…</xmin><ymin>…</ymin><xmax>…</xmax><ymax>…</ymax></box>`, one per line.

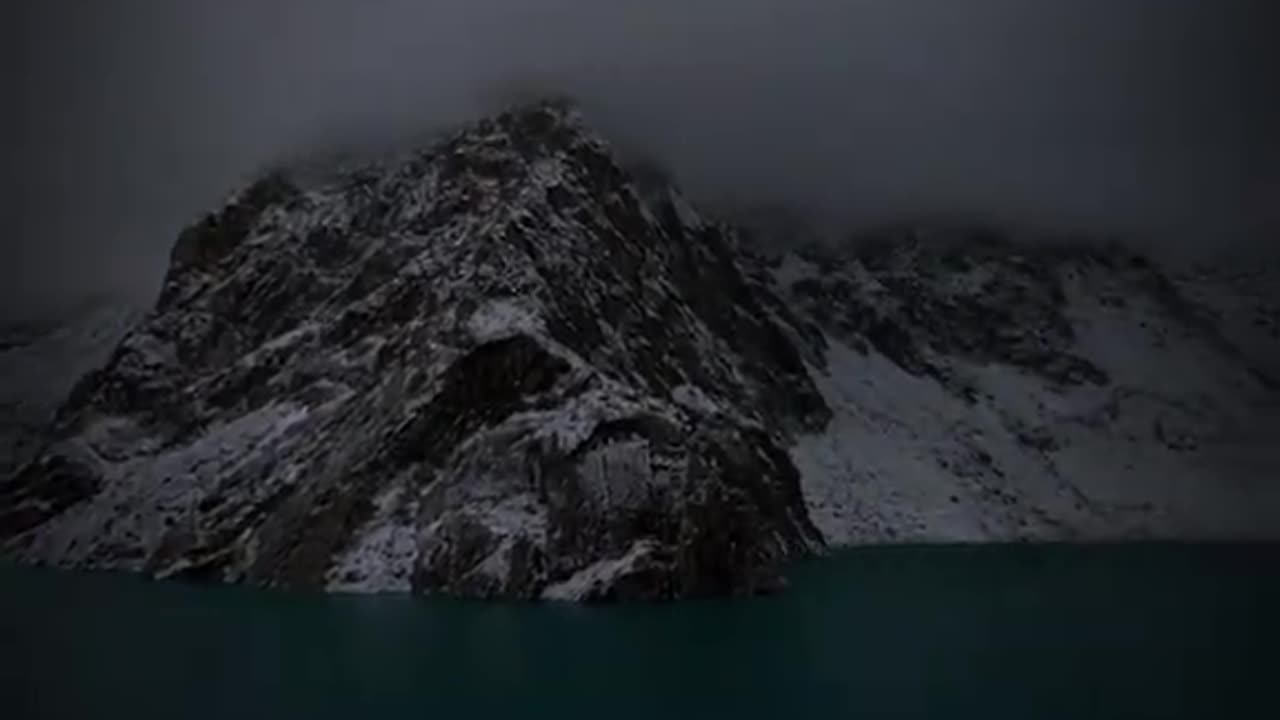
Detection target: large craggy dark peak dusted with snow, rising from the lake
<box><xmin>0</xmin><ymin>102</ymin><xmax>829</xmax><ymax>600</ymax></box>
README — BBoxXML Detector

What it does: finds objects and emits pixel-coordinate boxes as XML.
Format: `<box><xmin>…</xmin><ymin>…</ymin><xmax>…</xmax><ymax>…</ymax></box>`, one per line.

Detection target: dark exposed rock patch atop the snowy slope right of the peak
<box><xmin>790</xmin><ymin>227</ymin><xmax>1107</xmax><ymax>392</ymax></box>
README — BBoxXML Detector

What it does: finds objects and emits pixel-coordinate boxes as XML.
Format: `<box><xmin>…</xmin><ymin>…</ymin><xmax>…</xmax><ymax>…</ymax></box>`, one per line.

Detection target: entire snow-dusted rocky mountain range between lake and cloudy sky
<box><xmin>0</xmin><ymin>101</ymin><xmax>1280</xmax><ymax>600</ymax></box>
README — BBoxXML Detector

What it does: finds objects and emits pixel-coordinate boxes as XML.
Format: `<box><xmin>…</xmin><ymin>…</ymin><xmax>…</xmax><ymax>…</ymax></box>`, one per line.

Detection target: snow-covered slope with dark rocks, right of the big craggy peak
<box><xmin>773</xmin><ymin>231</ymin><xmax>1280</xmax><ymax>544</ymax></box>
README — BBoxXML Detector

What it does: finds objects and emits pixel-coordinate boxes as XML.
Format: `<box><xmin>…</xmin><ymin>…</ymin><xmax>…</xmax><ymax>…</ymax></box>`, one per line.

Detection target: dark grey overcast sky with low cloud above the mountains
<box><xmin>0</xmin><ymin>0</ymin><xmax>1280</xmax><ymax>313</ymax></box>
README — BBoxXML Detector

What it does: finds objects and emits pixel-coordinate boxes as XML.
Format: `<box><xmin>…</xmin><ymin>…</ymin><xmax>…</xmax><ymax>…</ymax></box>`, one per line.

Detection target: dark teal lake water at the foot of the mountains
<box><xmin>0</xmin><ymin>544</ymin><xmax>1280</xmax><ymax>720</ymax></box>
